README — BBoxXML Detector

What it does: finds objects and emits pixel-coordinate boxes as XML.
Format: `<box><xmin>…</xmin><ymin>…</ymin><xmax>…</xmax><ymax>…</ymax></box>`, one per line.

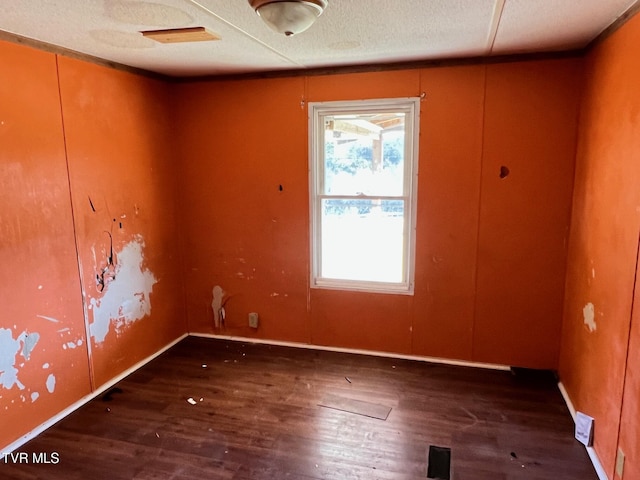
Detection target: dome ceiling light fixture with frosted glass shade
<box><xmin>249</xmin><ymin>0</ymin><xmax>329</xmax><ymax>37</ymax></box>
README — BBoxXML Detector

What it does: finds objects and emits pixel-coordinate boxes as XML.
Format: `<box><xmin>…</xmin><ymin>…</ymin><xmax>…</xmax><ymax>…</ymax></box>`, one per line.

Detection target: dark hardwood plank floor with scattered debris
<box><xmin>0</xmin><ymin>337</ymin><xmax>597</xmax><ymax>480</ymax></box>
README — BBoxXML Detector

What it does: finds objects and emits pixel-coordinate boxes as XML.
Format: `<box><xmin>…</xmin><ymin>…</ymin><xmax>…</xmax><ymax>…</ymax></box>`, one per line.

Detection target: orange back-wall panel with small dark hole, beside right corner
<box><xmin>473</xmin><ymin>61</ymin><xmax>582</xmax><ymax>369</ymax></box>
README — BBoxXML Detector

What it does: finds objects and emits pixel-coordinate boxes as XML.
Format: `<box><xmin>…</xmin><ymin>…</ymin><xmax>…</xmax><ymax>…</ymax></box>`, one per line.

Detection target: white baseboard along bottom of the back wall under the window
<box><xmin>189</xmin><ymin>333</ymin><xmax>511</xmax><ymax>371</ymax></box>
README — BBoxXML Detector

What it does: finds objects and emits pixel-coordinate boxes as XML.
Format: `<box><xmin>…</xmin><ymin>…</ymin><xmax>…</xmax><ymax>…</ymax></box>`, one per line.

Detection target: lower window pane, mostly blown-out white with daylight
<box><xmin>320</xmin><ymin>199</ymin><xmax>405</xmax><ymax>283</ymax></box>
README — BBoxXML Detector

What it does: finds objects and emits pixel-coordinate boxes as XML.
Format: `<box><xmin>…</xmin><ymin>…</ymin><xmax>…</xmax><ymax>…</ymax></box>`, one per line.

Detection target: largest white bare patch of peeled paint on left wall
<box><xmin>89</xmin><ymin>235</ymin><xmax>158</xmax><ymax>343</ymax></box>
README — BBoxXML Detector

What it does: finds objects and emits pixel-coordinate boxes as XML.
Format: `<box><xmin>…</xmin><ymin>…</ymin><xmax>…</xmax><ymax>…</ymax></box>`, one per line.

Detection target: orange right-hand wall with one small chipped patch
<box><xmin>560</xmin><ymin>16</ymin><xmax>640</xmax><ymax>479</ymax></box>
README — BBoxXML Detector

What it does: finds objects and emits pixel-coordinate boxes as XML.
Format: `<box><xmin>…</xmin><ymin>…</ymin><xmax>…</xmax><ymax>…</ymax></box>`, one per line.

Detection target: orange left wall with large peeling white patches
<box><xmin>0</xmin><ymin>42</ymin><xmax>186</xmax><ymax>451</ymax></box>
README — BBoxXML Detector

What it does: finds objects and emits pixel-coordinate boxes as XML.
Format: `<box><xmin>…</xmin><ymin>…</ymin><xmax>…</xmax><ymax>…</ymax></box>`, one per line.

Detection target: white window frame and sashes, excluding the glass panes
<box><xmin>308</xmin><ymin>97</ymin><xmax>420</xmax><ymax>295</ymax></box>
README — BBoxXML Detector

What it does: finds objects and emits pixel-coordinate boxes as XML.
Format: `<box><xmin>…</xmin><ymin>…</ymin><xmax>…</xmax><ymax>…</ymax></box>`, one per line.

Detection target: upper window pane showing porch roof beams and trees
<box><xmin>323</xmin><ymin>112</ymin><xmax>405</xmax><ymax>196</ymax></box>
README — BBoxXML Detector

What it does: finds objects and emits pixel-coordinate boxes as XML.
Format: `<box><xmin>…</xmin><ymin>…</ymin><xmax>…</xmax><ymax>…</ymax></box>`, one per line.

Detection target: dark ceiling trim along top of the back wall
<box><xmin>171</xmin><ymin>49</ymin><xmax>585</xmax><ymax>83</ymax></box>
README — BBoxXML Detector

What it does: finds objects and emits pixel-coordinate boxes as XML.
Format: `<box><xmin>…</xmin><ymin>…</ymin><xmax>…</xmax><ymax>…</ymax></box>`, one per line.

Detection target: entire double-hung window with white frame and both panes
<box><xmin>309</xmin><ymin>98</ymin><xmax>420</xmax><ymax>294</ymax></box>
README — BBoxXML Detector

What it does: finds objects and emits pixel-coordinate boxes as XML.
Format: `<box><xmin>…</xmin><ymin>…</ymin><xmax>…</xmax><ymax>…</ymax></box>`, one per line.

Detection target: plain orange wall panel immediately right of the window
<box><xmin>412</xmin><ymin>66</ymin><xmax>486</xmax><ymax>360</ymax></box>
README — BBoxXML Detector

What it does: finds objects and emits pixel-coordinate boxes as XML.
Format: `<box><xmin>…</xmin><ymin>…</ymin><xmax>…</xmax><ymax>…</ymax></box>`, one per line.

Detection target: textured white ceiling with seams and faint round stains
<box><xmin>0</xmin><ymin>0</ymin><xmax>640</xmax><ymax>76</ymax></box>
